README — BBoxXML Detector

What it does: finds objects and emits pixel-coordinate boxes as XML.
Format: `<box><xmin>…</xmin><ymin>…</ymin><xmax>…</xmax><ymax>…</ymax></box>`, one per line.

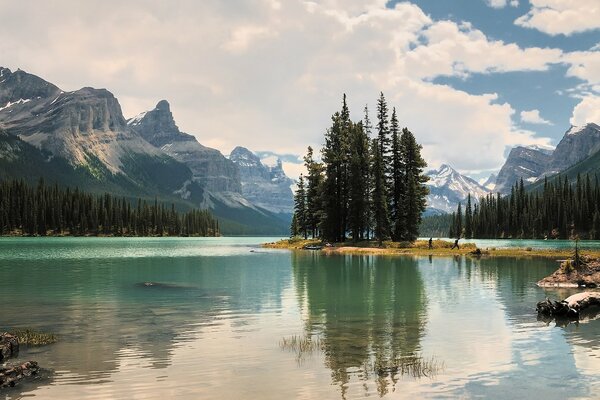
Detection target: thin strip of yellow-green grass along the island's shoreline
<box><xmin>263</xmin><ymin>238</ymin><xmax>600</xmax><ymax>258</ymax></box>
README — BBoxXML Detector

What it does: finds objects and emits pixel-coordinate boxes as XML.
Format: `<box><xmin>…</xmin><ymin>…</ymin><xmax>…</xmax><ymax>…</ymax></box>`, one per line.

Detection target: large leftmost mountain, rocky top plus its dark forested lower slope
<box><xmin>0</xmin><ymin>68</ymin><xmax>191</xmax><ymax>196</ymax></box>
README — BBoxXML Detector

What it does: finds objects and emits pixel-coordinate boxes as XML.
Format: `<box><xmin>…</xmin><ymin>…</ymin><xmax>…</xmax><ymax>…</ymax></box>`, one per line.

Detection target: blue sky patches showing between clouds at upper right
<box><xmin>410</xmin><ymin>0</ymin><xmax>600</xmax><ymax>150</ymax></box>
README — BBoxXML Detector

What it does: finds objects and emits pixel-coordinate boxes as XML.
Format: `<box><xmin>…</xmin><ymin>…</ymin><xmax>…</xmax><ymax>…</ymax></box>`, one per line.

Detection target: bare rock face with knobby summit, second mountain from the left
<box><xmin>127</xmin><ymin>100</ymin><xmax>242</xmax><ymax>193</ymax></box>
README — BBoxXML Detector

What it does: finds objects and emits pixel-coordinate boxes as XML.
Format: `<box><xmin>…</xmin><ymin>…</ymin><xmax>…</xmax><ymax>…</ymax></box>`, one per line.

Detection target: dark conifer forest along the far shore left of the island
<box><xmin>0</xmin><ymin>180</ymin><xmax>219</xmax><ymax>236</ymax></box>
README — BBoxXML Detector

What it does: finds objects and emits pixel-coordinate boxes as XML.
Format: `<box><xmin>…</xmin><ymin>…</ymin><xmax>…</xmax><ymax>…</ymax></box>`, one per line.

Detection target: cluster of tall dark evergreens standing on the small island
<box><xmin>291</xmin><ymin>93</ymin><xmax>428</xmax><ymax>242</ymax></box>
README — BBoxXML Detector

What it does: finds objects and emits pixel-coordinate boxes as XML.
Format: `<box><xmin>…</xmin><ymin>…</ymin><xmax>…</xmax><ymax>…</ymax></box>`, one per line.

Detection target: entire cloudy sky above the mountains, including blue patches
<box><xmin>0</xmin><ymin>0</ymin><xmax>600</xmax><ymax>178</ymax></box>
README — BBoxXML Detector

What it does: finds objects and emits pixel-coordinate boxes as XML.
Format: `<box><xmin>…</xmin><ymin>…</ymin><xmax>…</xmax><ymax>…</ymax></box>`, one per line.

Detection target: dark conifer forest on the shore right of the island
<box><xmin>449</xmin><ymin>175</ymin><xmax>600</xmax><ymax>239</ymax></box>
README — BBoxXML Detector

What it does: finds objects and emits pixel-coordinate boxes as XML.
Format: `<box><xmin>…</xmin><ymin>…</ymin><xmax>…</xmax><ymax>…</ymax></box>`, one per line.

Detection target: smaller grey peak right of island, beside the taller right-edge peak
<box><xmin>494</xmin><ymin>146</ymin><xmax>552</xmax><ymax>194</ymax></box>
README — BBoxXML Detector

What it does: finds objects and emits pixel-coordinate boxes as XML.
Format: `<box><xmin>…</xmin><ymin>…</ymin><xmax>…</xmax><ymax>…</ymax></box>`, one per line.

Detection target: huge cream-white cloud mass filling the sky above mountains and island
<box><xmin>0</xmin><ymin>0</ymin><xmax>561</xmax><ymax>170</ymax></box>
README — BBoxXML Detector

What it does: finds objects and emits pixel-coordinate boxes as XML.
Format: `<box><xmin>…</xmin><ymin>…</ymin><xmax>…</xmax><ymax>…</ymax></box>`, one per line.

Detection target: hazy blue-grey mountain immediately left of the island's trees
<box><xmin>229</xmin><ymin>146</ymin><xmax>294</xmax><ymax>219</ymax></box>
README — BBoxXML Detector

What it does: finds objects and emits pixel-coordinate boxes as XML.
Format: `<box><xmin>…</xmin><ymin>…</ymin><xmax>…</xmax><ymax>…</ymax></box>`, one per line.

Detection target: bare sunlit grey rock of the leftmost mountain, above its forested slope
<box><xmin>0</xmin><ymin>68</ymin><xmax>160</xmax><ymax>175</ymax></box>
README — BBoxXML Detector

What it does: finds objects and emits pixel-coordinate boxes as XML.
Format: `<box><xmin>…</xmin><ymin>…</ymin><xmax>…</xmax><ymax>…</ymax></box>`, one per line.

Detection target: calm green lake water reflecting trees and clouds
<box><xmin>0</xmin><ymin>238</ymin><xmax>600</xmax><ymax>399</ymax></box>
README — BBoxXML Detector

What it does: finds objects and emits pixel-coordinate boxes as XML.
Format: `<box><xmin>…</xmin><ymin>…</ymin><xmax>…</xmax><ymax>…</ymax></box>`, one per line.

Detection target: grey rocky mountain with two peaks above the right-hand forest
<box><xmin>496</xmin><ymin>123</ymin><xmax>600</xmax><ymax>194</ymax></box>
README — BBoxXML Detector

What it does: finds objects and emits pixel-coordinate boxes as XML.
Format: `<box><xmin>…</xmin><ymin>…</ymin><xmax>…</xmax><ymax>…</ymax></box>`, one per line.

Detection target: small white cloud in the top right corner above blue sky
<box><xmin>515</xmin><ymin>0</ymin><xmax>600</xmax><ymax>36</ymax></box>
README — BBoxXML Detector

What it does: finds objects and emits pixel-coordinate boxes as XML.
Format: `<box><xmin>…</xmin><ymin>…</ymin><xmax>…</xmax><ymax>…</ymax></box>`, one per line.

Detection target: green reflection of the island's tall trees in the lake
<box><xmin>292</xmin><ymin>253</ymin><xmax>427</xmax><ymax>397</ymax></box>
